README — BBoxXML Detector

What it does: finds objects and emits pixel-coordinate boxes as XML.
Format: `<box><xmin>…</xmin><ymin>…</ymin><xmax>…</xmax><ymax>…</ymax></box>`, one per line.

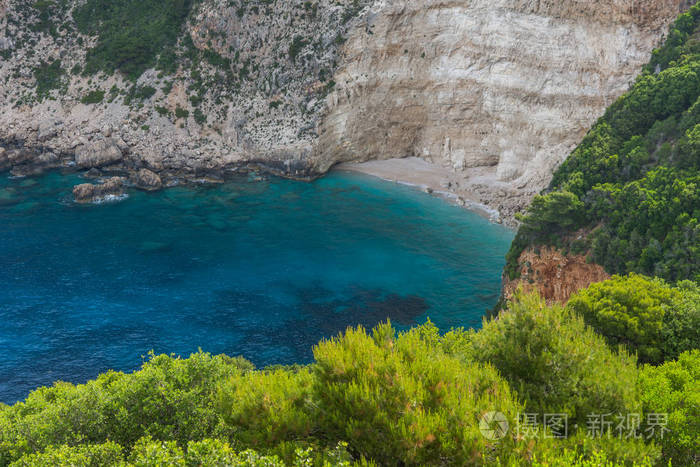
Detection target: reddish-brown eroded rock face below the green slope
<box><xmin>503</xmin><ymin>247</ymin><xmax>610</xmax><ymax>304</ymax></box>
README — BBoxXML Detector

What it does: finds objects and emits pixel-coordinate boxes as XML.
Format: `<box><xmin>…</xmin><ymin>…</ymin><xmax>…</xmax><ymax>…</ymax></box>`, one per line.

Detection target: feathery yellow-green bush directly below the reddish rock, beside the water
<box><xmin>472</xmin><ymin>295</ymin><xmax>639</xmax><ymax>426</ymax></box>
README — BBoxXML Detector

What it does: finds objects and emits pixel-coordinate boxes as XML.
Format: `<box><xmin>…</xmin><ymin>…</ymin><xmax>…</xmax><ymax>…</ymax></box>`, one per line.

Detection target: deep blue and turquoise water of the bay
<box><xmin>0</xmin><ymin>173</ymin><xmax>513</xmax><ymax>403</ymax></box>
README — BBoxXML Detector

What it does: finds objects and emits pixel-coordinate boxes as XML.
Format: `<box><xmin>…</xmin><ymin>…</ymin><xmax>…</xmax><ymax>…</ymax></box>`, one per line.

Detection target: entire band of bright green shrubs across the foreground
<box><xmin>0</xmin><ymin>295</ymin><xmax>700</xmax><ymax>466</ymax></box>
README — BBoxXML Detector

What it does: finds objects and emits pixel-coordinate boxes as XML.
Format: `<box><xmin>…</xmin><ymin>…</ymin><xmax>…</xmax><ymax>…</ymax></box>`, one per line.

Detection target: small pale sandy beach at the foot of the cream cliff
<box><xmin>332</xmin><ymin>157</ymin><xmax>513</xmax><ymax>229</ymax></box>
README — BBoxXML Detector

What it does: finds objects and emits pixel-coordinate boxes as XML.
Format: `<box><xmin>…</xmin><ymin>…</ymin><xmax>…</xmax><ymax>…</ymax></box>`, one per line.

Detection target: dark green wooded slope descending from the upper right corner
<box><xmin>506</xmin><ymin>5</ymin><xmax>700</xmax><ymax>281</ymax></box>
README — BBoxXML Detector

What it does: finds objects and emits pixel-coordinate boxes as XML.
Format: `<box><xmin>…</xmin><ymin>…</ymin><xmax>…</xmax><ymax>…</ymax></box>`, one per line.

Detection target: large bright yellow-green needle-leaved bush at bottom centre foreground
<box><xmin>314</xmin><ymin>325</ymin><xmax>520</xmax><ymax>465</ymax></box>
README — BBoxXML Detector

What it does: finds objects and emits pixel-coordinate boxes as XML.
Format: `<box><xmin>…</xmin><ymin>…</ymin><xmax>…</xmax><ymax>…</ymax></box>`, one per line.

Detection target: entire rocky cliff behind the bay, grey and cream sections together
<box><xmin>0</xmin><ymin>0</ymin><xmax>686</xmax><ymax>218</ymax></box>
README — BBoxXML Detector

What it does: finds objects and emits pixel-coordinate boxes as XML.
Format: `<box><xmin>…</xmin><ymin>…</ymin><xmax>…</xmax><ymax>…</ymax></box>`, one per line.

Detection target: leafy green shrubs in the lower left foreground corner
<box><xmin>0</xmin><ymin>353</ymin><xmax>252</xmax><ymax>465</ymax></box>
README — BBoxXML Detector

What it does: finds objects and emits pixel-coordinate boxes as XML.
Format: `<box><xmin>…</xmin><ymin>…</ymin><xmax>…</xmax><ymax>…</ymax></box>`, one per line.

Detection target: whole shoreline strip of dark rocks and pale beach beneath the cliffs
<box><xmin>0</xmin><ymin>139</ymin><xmax>522</xmax><ymax>230</ymax></box>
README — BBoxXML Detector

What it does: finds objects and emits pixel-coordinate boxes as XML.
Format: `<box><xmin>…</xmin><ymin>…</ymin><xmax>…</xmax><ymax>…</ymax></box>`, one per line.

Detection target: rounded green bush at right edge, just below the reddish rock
<box><xmin>567</xmin><ymin>274</ymin><xmax>700</xmax><ymax>364</ymax></box>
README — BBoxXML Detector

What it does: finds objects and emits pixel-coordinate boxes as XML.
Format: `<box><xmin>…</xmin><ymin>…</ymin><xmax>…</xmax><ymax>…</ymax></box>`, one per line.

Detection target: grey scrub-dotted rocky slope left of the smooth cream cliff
<box><xmin>0</xmin><ymin>0</ymin><xmax>370</xmax><ymax>178</ymax></box>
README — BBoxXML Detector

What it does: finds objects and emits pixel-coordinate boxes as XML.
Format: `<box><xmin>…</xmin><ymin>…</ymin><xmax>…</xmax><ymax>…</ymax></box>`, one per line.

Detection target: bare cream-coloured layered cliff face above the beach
<box><xmin>316</xmin><ymin>0</ymin><xmax>685</xmax><ymax>219</ymax></box>
